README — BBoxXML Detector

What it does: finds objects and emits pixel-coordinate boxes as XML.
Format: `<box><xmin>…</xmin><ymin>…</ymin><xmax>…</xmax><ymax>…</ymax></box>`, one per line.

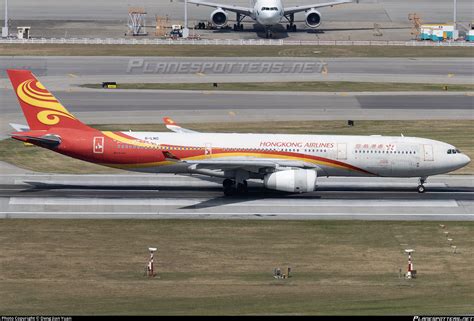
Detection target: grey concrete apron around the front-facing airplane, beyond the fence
<box><xmin>0</xmin><ymin>0</ymin><xmax>474</xmax><ymax>40</ymax></box>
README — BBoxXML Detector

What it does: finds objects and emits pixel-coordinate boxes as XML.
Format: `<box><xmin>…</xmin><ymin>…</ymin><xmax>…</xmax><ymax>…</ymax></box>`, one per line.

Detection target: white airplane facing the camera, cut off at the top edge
<box><xmin>188</xmin><ymin>0</ymin><xmax>352</xmax><ymax>38</ymax></box>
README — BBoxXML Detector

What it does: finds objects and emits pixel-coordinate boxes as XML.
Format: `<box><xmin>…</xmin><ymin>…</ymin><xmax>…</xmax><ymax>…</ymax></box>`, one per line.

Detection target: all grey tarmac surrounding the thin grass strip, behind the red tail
<box><xmin>0</xmin><ymin>57</ymin><xmax>474</xmax><ymax>137</ymax></box>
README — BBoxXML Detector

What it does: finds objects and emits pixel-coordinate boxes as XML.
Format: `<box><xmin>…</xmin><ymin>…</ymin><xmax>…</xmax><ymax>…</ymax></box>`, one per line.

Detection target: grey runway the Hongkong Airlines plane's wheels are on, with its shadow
<box><xmin>0</xmin><ymin>174</ymin><xmax>474</xmax><ymax>221</ymax></box>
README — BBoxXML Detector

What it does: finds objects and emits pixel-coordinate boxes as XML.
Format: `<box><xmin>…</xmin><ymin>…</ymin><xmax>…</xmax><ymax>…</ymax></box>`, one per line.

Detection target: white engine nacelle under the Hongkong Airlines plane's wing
<box><xmin>264</xmin><ymin>169</ymin><xmax>318</xmax><ymax>193</ymax></box>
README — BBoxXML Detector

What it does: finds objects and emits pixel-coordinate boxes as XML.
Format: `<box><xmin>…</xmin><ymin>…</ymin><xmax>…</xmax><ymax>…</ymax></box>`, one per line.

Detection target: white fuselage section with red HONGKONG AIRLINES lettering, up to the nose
<box><xmin>116</xmin><ymin>132</ymin><xmax>470</xmax><ymax>177</ymax></box>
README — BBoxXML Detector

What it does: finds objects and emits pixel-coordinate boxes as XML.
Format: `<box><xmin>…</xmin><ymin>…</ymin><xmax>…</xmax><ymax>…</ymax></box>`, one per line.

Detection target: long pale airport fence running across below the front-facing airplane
<box><xmin>0</xmin><ymin>38</ymin><xmax>474</xmax><ymax>47</ymax></box>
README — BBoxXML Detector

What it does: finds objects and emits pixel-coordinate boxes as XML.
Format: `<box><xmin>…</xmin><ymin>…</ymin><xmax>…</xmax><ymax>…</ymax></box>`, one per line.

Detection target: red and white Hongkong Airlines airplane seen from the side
<box><xmin>3</xmin><ymin>70</ymin><xmax>470</xmax><ymax>196</ymax></box>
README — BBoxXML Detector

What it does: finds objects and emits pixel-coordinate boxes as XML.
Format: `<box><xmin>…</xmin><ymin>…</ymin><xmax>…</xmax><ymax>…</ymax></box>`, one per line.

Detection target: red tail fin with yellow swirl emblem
<box><xmin>7</xmin><ymin>69</ymin><xmax>90</xmax><ymax>130</ymax></box>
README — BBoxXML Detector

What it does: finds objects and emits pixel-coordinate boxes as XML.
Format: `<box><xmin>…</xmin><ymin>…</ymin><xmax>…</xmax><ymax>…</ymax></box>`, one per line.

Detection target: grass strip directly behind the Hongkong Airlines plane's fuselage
<box><xmin>0</xmin><ymin>119</ymin><xmax>474</xmax><ymax>174</ymax></box>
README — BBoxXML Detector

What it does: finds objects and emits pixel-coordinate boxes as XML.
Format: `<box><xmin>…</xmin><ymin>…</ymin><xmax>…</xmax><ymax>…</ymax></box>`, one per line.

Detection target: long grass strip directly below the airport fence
<box><xmin>0</xmin><ymin>44</ymin><xmax>474</xmax><ymax>58</ymax></box>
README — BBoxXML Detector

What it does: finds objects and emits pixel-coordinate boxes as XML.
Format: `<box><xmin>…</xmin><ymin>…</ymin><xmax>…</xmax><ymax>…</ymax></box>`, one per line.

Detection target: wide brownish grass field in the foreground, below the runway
<box><xmin>0</xmin><ymin>220</ymin><xmax>474</xmax><ymax>315</ymax></box>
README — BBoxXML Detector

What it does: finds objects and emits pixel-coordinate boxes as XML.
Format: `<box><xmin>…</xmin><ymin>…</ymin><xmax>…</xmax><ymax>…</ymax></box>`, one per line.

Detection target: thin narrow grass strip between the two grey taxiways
<box><xmin>81</xmin><ymin>81</ymin><xmax>474</xmax><ymax>92</ymax></box>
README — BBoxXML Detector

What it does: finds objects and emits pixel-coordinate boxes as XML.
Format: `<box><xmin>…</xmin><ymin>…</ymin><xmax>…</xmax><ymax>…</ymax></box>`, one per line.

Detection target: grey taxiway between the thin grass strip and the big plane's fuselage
<box><xmin>0</xmin><ymin>89</ymin><xmax>474</xmax><ymax>138</ymax></box>
